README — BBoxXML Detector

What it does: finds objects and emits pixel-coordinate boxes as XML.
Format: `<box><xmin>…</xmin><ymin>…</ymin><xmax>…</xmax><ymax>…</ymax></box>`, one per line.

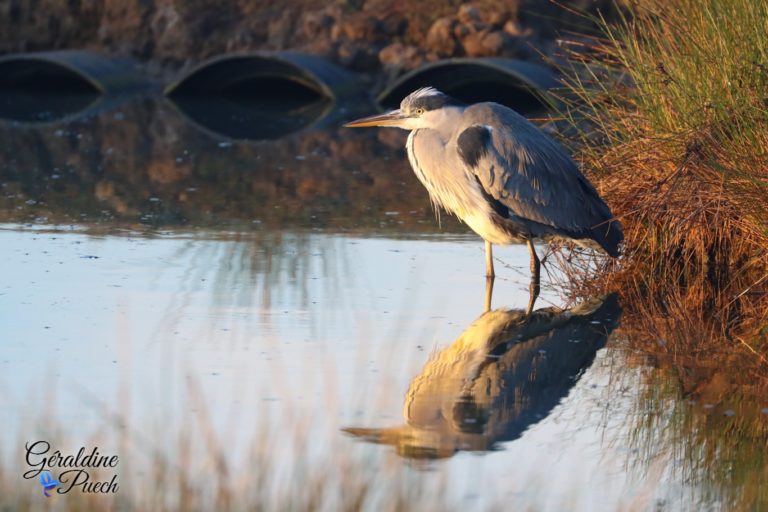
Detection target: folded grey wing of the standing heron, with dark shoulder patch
<box><xmin>457</xmin><ymin>103</ymin><xmax>623</xmax><ymax>255</ymax></box>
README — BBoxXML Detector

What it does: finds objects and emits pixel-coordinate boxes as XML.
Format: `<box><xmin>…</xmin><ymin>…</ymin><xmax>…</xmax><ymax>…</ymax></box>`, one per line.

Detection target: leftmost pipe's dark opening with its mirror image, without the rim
<box><xmin>0</xmin><ymin>59</ymin><xmax>101</xmax><ymax>123</ymax></box>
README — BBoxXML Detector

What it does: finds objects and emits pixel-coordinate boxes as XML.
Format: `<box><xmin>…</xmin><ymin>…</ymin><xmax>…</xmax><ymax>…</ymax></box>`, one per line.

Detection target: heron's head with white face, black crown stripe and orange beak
<box><xmin>344</xmin><ymin>87</ymin><xmax>464</xmax><ymax>130</ymax></box>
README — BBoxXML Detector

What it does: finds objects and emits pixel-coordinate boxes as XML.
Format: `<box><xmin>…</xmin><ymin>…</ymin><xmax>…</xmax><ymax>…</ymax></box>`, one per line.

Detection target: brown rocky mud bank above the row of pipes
<box><xmin>0</xmin><ymin>0</ymin><xmax>610</xmax><ymax>86</ymax></box>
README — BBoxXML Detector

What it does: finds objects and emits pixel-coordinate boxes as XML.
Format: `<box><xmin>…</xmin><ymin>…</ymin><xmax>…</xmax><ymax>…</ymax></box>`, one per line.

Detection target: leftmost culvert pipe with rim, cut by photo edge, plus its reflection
<box><xmin>0</xmin><ymin>50</ymin><xmax>147</xmax><ymax>126</ymax></box>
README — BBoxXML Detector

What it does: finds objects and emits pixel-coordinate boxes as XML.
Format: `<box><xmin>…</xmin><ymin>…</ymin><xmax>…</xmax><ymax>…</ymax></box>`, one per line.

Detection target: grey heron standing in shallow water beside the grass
<box><xmin>345</xmin><ymin>87</ymin><xmax>624</xmax><ymax>311</ymax></box>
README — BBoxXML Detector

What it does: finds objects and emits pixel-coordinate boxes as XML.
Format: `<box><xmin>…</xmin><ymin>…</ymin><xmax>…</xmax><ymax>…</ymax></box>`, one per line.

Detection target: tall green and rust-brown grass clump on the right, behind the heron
<box><xmin>566</xmin><ymin>0</ymin><xmax>768</xmax><ymax>350</ymax></box>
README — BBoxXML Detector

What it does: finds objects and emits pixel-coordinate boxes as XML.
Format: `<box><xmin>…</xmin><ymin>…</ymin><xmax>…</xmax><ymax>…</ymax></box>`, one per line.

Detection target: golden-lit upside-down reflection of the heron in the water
<box><xmin>344</xmin><ymin>295</ymin><xmax>621</xmax><ymax>458</ymax></box>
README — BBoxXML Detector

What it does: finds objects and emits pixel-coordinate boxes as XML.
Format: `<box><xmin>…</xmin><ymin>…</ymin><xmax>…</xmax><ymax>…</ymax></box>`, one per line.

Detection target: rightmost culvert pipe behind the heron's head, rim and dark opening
<box><xmin>378</xmin><ymin>58</ymin><xmax>560</xmax><ymax>115</ymax></box>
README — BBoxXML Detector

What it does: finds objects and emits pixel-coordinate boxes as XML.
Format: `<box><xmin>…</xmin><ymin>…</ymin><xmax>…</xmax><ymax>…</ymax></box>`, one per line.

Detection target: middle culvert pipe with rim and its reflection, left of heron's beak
<box><xmin>165</xmin><ymin>52</ymin><xmax>361</xmax><ymax>140</ymax></box>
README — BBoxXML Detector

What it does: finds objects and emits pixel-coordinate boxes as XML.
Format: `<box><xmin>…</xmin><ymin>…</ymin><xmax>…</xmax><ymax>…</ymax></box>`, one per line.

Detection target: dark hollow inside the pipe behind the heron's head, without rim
<box><xmin>379</xmin><ymin>64</ymin><xmax>547</xmax><ymax>115</ymax></box>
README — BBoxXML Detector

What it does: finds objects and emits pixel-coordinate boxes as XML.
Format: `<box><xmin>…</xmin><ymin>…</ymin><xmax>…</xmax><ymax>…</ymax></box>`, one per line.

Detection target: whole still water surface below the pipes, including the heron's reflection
<box><xmin>0</xmin><ymin>98</ymin><xmax>768</xmax><ymax>511</ymax></box>
